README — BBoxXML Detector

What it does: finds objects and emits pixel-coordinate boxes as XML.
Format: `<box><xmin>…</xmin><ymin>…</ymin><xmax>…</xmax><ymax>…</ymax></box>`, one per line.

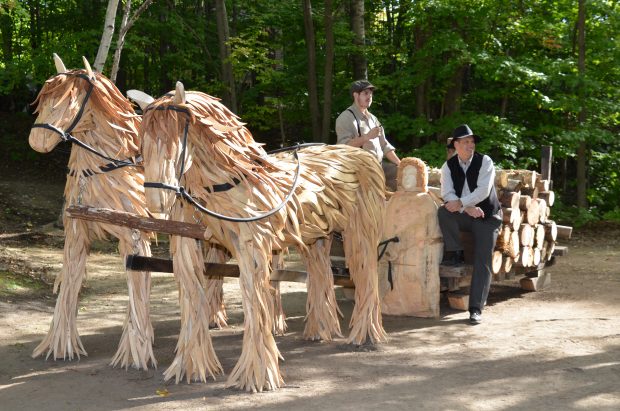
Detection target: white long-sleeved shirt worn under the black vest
<box><xmin>441</xmin><ymin>155</ymin><xmax>495</xmax><ymax>212</ymax></box>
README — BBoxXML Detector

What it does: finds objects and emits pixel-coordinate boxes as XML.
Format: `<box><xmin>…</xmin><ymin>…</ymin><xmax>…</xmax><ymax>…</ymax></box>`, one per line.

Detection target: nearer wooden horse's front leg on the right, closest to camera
<box><xmin>227</xmin><ymin>232</ymin><xmax>284</xmax><ymax>392</ymax></box>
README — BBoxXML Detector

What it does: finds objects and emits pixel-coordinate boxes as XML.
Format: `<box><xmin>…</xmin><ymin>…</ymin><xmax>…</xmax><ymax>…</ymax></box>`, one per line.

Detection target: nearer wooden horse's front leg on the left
<box><xmin>164</xmin><ymin>236</ymin><xmax>223</xmax><ymax>384</ymax></box>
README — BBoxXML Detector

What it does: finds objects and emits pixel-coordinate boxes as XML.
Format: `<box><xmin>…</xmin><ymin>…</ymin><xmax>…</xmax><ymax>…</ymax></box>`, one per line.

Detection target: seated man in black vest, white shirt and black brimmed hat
<box><xmin>438</xmin><ymin>124</ymin><xmax>502</xmax><ymax>324</ymax></box>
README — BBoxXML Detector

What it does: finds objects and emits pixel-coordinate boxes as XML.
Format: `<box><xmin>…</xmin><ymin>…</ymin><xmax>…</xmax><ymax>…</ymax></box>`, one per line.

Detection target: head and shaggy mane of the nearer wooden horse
<box><xmin>140</xmin><ymin>82</ymin><xmax>269</xmax><ymax>220</ymax></box>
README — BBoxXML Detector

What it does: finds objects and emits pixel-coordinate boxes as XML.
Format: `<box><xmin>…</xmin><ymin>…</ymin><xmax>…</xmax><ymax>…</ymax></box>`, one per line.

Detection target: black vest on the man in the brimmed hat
<box><xmin>447</xmin><ymin>152</ymin><xmax>501</xmax><ymax>219</ymax></box>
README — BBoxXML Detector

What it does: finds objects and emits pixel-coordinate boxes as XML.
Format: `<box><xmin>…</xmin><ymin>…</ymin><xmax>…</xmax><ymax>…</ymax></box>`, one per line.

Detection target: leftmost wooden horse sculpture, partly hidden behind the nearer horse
<box><xmin>29</xmin><ymin>55</ymin><xmax>156</xmax><ymax>369</ymax></box>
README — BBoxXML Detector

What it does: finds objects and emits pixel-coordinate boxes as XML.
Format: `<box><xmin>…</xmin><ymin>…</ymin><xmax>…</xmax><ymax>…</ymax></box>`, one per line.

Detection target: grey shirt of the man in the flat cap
<box><xmin>336</xmin><ymin>104</ymin><xmax>395</xmax><ymax>162</ymax></box>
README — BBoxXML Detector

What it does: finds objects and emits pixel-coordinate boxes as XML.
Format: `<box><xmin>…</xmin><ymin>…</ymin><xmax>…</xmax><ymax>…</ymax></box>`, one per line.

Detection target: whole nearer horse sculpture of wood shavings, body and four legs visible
<box><xmin>141</xmin><ymin>83</ymin><xmax>386</xmax><ymax>391</ymax></box>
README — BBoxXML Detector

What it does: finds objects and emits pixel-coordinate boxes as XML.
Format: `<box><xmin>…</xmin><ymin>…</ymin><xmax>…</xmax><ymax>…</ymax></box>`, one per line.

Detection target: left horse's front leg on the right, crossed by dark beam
<box><xmin>110</xmin><ymin>229</ymin><xmax>157</xmax><ymax>369</ymax></box>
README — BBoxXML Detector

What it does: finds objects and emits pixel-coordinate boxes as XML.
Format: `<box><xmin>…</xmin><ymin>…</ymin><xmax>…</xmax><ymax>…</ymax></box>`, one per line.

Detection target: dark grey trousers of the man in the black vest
<box><xmin>438</xmin><ymin>207</ymin><xmax>502</xmax><ymax>312</ymax></box>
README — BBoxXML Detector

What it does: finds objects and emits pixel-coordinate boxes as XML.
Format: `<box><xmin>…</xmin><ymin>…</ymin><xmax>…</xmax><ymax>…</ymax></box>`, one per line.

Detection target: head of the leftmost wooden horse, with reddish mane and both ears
<box><xmin>28</xmin><ymin>54</ymin><xmax>140</xmax><ymax>157</ymax></box>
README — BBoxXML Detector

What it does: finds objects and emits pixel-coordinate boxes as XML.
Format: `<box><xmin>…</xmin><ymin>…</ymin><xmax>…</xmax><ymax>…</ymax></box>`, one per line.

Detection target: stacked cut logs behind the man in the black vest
<box><xmin>429</xmin><ymin>169</ymin><xmax>572</xmax><ymax>279</ymax></box>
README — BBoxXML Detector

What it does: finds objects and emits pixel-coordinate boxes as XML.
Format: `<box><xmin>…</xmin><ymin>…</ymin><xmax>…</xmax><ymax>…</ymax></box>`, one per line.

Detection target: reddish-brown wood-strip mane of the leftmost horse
<box><xmin>32</xmin><ymin>69</ymin><xmax>141</xmax><ymax>154</ymax></box>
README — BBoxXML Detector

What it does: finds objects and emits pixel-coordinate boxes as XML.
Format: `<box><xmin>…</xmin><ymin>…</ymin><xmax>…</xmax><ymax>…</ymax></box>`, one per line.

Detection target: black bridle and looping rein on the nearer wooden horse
<box><xmin>144</xmin><ymin>105</ymin><xmax>316</xmax><ymax>223</ymax></box>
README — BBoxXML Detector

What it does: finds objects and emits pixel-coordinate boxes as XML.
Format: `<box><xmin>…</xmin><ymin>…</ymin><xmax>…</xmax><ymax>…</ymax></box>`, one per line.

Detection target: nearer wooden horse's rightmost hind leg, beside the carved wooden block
<box><xmin>343</xmin><ymin>208</ymin><xmax>387</xmax><ymax>345</ymax></box>
